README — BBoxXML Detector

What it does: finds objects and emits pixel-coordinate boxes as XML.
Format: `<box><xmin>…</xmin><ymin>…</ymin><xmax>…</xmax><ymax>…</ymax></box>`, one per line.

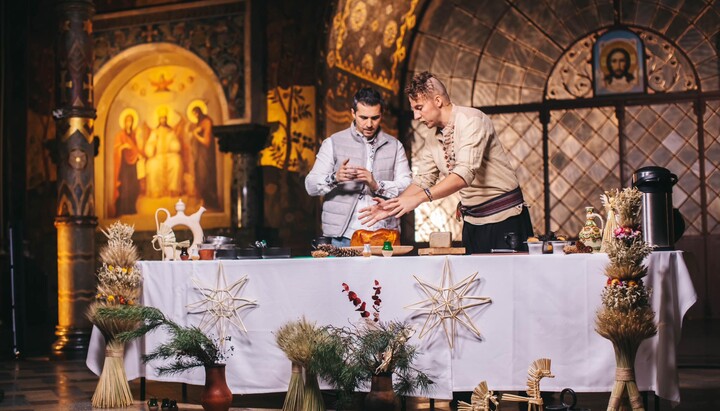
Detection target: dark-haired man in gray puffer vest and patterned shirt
<box><xmin>305</xmin><ymin>88</ymin><xmax>412</xmax><ymax>247</ymax></box>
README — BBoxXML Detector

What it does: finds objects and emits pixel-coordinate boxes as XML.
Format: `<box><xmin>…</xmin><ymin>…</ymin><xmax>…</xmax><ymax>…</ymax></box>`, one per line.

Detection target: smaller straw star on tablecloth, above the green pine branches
<box><xmin>187</xmin><ymin>263</ymin><xmax>257</xmax><ymax>343</ymax></box>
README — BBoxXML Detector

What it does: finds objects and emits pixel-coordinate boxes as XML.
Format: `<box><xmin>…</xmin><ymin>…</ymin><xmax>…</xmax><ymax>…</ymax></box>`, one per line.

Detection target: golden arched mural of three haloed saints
<box><xmin>104</xmin><ymin>65</ymin><xmax>228</xmax><ymax>222</ymax></box>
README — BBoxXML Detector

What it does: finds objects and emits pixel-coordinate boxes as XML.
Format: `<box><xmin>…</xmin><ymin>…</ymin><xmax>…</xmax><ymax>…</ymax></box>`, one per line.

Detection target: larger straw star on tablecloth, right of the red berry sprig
<box><xmin>405</xmin><ymin>258</ymin><xmax>492</xmax><ymax>350</ymax></box>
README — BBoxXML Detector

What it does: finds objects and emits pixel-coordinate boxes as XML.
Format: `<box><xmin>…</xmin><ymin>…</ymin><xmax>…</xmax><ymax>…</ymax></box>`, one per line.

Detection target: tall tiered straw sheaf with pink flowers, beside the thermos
<box><xmin>595</xmin><ymin>188</ymin><xmax>657</xmax><ymax>411</ymax></box>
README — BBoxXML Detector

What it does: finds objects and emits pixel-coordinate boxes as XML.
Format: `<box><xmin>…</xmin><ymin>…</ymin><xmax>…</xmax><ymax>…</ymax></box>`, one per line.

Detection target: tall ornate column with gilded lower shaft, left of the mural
<box><xmin>52</xmin><ymin>0</ymin><xmax>97</xmax><ymax>358</ymax></box>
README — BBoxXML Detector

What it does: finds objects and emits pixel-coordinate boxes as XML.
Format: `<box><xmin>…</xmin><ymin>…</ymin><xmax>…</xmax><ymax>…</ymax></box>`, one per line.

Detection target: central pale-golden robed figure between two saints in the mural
<box><xmin>145</xmin><ymin>107</ymin><xmax>183</xmax><ymax>198</ymax></box>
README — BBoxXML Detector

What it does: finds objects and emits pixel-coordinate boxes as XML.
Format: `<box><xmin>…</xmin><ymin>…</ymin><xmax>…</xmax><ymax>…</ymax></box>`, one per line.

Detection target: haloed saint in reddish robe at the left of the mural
<box><xmin>110</xmin><ymin>108</ymin><xmax>143</xmax><ymax>216</ymax></box>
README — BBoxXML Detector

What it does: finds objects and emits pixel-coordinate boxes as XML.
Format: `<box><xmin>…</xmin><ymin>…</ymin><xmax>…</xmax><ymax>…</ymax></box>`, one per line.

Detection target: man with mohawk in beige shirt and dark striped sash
<box><xmin>360</xmin><ymin>71</ymin><xmax>533</xmax><ymax>254</ymax></box>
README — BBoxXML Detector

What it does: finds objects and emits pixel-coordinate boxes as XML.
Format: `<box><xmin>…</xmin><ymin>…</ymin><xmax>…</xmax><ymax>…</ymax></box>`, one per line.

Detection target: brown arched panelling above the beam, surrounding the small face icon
<box><xmin>409</xmin><ymin>0</ymin><xmax>720</xmax><ymax>106</ymax></box>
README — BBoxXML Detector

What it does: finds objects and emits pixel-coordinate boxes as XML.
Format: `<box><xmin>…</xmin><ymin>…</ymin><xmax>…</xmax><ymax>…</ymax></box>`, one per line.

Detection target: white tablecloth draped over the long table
<box><xmin>87</xmin><ymin>251</ymin><xmax>696</xmax><ymax>402</ymax></box>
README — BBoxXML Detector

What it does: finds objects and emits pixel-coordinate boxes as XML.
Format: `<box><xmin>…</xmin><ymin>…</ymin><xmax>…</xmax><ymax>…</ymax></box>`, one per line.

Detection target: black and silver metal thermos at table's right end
<box><xmin>633</xmin><ymin>166</ymin><xmax>678</xmax><ymax>250</ymax></box>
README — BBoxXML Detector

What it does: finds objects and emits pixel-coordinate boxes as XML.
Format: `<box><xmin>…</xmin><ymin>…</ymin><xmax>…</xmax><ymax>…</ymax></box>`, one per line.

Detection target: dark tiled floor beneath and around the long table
<box><xmin>0</xmin><ymin>321</ymin><xmax>720</xmax><ymax>411</ymax></box>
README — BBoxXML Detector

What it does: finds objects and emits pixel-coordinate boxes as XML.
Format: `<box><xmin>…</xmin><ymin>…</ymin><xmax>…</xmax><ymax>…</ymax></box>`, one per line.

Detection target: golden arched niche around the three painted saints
<box><xmin>94</xmin><ymin>43</ymin><xmax>231</xmax><ymax>235</ymax></box>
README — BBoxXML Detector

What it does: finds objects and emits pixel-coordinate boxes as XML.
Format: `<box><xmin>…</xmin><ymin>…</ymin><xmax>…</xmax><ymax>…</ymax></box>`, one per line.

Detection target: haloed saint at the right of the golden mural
<box><xmin>188</xmin><ymin>102</ymin><xmax>220</xmax><ymax>209</ymax></box>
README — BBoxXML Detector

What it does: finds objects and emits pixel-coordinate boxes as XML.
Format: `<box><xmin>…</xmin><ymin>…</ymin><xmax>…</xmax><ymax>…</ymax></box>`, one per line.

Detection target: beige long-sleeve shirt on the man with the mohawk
<box><xmin>413</xmin><ymin>105</ymin><xmax>522</xmax><ymax>225</ymax></box>
